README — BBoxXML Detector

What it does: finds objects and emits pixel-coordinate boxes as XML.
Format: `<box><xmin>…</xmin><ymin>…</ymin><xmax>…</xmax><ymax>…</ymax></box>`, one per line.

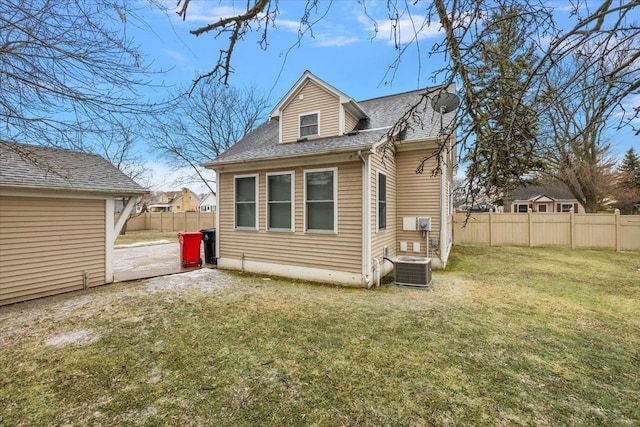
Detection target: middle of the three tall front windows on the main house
<box><xmin>267</xmin><ymin>172</ymin><xmax>294</xmax><ymax>230</ymax></box>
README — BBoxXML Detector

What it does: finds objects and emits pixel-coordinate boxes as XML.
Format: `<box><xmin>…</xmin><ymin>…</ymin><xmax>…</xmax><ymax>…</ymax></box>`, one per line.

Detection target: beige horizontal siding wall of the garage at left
<box><xmin>0</xmin><ymin>196</ymin><xmax>106</xmax><ymax>305</ymax></box>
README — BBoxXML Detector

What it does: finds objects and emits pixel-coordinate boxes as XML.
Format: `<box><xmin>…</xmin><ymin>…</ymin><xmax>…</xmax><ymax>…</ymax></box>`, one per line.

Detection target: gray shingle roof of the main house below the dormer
<box><xmin>205</xmin><ymin>87</ymin><xmax>455</xmax><ymax>166</ymax></box>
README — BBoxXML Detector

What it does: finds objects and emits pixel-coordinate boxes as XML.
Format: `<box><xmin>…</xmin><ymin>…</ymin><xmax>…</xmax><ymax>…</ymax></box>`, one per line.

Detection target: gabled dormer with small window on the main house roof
<box><xmin>269</xmin><ymin>71</ymin><xmax>367</xmax><ymax>143</ymax></box>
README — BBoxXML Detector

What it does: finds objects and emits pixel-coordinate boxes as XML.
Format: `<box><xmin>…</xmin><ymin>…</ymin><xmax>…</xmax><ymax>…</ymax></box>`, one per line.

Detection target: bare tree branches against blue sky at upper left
<box><xmin>0</xmin><ymin>0</ymin><xmax>170</xmax><ymax>150</ymax></box>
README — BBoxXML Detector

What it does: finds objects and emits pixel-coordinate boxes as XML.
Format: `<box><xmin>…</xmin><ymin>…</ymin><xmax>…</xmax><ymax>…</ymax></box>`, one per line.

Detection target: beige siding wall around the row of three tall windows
<box><xmin>218</xmin><ymin>161</ymin><xmax>362</xmax><ymax>273</ymax></box>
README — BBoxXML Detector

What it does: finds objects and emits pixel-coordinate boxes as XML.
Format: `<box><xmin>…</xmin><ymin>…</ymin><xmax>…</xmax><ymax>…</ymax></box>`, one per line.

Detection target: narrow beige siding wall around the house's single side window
<box><xmin>370</xmin><ymin>149</ymin><xmax>397</xmax><ymax>261</ymax></box>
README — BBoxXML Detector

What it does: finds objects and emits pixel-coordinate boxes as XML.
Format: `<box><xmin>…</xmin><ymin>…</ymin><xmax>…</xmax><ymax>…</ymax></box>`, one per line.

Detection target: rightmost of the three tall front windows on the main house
<box><xmin>304</xmin><ymin>168</ymin><xmax>338</xmax><ymax>233</ymax></box>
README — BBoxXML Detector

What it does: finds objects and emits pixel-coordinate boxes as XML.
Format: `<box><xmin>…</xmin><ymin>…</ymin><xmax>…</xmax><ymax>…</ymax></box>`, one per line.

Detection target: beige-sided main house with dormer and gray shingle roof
<box><xmin>205</xmin><ymin>71</ymin><xmax>456</xmax><ymax>286</ymax></box>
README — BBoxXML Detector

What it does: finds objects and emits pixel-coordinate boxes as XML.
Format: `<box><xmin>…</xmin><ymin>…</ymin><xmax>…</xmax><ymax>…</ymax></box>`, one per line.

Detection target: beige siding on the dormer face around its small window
<box><xmin>280</xmin><ymin>81</ymin><xmax>340</xmax><ymax>143</ymax></box>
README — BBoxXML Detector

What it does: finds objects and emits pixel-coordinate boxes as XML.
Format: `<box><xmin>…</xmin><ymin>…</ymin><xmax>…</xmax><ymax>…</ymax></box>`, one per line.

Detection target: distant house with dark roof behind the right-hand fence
<box><xmin>505</xmin><ymin>184</ymin><xmax>585</xmax><ymax>213</ymax></box>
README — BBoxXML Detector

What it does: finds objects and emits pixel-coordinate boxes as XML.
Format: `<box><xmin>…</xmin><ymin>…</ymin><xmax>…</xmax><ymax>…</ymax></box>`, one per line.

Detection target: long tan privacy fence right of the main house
<box><xmin>453</xmin><ymin>211</ymin><xmax>640</xmax><ymax>251</ymax></box>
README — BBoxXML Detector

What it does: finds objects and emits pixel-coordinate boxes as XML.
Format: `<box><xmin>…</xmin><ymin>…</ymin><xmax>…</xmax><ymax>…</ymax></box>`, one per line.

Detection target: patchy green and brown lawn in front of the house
<box><xmin>0</xmin><ymin>247</ymin><xmax>640</xmax><ymax>426</ymax></box>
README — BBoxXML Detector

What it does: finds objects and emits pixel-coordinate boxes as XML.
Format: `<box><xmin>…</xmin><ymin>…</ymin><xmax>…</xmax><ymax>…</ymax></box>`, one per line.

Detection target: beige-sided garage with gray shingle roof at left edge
<box><xmin>0</xmin><ymin>141</ymin><xmax>147</xmax><ymax>305</ymax></box>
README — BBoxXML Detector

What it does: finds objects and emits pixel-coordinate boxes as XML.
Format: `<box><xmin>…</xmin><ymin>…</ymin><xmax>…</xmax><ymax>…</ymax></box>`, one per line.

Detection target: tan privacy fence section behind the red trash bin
<box><xmin>127</xmin><ymin>212</ymin><xmax>216</xmax><ymax>231</ymax></box>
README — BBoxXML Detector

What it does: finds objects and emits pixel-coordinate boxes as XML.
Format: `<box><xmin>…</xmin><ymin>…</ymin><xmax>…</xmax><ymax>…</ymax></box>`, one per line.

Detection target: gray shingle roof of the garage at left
<box><xmin>0</xmin><ymin>141</ymin><xmax>148</xmax><ymax>195</ymax></box>
